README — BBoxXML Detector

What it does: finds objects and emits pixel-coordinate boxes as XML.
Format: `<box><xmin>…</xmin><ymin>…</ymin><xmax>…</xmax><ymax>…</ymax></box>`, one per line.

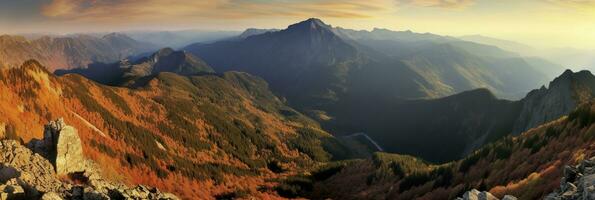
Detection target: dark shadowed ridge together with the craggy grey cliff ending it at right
<box><xmin>344</xmin><ymin>70</ymin><xmax>595</xmax><ymax>162</ymax></box>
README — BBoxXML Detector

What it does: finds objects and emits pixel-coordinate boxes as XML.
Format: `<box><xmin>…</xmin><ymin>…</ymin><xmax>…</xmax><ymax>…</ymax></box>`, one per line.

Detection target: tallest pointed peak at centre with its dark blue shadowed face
<box><xmin>185</xmin><ymin>19</ymin><xmax>425</xmax><ymax>109</ymax></box>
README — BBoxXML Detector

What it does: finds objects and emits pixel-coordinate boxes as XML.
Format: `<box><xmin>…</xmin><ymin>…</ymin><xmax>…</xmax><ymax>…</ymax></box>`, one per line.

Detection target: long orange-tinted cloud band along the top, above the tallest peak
<box><xmin>41</xmin><ymin>0</ymin><xmax>394</xmax><ymax>21</ymax></box>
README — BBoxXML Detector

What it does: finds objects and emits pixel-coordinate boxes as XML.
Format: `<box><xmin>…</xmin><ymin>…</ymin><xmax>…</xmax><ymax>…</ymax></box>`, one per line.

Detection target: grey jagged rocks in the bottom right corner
<box><xmin>545</xmin><ymin>157</ymin><xmax>595</xmax><ymax>200</ymax></box>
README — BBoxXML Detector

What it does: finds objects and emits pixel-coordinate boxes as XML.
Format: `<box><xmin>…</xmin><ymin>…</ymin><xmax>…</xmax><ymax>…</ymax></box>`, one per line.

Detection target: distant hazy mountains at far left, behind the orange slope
<box><xmin>0</xmin><ymin>33</ymin><xmax>156</xmax><ymax>71</ymax></box>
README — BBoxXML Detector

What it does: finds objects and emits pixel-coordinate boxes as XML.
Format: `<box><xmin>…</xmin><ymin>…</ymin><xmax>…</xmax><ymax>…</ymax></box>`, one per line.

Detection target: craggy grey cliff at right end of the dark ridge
<box><xmin>513</xmin><ymin>70</ymin><xmax>595</xmax><ymax>134</ymax></box>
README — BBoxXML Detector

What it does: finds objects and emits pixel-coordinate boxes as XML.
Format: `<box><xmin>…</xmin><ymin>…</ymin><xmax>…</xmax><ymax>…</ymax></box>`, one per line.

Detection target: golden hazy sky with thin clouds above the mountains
<box><xmin>0</xmin><ymin>0</ymin><xmax>595</xmax><ymax>49</ymax></box>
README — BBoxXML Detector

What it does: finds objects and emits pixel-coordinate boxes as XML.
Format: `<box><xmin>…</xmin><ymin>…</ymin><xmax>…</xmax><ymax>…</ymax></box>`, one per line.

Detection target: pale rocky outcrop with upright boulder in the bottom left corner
<box><xmin>0</xmin><ymin>120</ymin><xmax>178</xmax><ymax>200</ymax></box>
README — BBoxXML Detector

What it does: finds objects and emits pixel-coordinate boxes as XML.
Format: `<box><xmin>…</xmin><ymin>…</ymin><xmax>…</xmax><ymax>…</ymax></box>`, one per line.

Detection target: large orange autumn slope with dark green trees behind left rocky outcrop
<box><xmin>0</xmin><ymin>61</ymin><xmax>366</xmax><ymax>199</ymax></box>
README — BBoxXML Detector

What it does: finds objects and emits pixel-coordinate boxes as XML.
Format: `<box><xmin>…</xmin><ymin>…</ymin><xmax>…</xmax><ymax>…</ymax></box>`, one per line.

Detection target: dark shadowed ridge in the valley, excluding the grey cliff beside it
<box><xmin>353</xmin><ymin>89</ymin><xmax>522</xmax><ymax>162</ymax></box>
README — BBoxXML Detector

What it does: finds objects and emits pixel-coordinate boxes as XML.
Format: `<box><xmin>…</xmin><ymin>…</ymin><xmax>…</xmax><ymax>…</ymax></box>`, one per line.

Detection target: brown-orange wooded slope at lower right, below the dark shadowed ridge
<box><xmin>282</xmin><ymin>102</ymin><xmax>595</xmax><ymax>200</ymax></box>
